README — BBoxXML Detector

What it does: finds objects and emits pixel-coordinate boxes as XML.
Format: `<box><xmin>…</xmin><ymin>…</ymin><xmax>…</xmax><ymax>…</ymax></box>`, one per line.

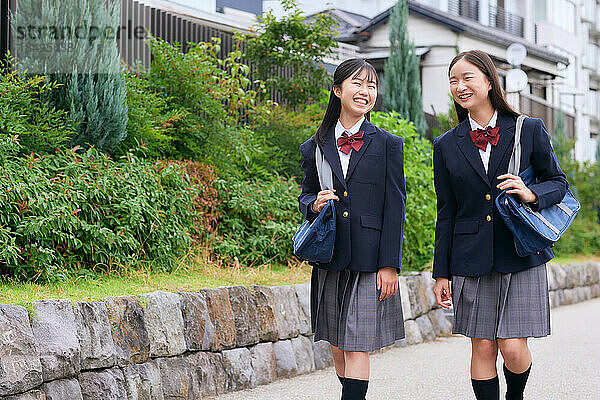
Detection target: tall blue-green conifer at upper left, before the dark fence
<box><xmin>11</xmin><ymin>0</ymin><xmax>127</xmax><ymax>151</ymax></box>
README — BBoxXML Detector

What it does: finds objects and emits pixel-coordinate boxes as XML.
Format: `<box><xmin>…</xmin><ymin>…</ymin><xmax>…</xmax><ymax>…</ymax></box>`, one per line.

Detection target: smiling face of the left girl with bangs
<box><xmin>333</xmin><ymin>68</ymin><xmax>377</xmax><ymax>119</ymax></box>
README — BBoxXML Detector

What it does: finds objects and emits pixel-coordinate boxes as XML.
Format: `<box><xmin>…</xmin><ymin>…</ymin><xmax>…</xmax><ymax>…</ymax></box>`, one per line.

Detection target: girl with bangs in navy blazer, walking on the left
<box><xmin>298</xmin><ymin>59</ymin><xmax>406</xmax><ymax>400</ymax></box>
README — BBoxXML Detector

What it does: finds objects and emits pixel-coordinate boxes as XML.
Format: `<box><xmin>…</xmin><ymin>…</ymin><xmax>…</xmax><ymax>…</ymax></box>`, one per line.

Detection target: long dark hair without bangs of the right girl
<box><xmin>448</xmin><ymin>50</ymin><xmax>519</xmax><ymax>122</ymax></box>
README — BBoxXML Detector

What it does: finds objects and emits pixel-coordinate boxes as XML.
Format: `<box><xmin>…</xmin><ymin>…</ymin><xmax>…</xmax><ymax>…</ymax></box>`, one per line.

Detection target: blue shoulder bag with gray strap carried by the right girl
<box><xmin>496</xmin><ymin>115</ymin><xmax>580</xmax><ymax>257</ymax></box>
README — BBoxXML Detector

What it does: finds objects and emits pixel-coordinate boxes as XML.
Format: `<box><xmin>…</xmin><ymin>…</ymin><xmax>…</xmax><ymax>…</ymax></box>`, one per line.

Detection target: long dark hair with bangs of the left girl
<box><xmin>312</xmin><ymin>58</ymin><xmax>379</xmax><ymax>145</ymax></box>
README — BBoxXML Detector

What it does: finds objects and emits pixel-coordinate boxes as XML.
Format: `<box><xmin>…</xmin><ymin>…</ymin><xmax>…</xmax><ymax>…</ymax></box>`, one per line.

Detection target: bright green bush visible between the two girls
<box><xmin>371</xmin><ymin>111</ymin><xmax>436</xmax><ymax>270</ymax></box>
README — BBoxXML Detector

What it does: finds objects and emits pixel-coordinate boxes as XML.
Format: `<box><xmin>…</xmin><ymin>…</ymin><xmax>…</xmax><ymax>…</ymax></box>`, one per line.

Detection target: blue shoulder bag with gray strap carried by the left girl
<box><xmin>292</xmin><ymin>145</ymin><xmax>335</xmax><ymax>263</ymax></box>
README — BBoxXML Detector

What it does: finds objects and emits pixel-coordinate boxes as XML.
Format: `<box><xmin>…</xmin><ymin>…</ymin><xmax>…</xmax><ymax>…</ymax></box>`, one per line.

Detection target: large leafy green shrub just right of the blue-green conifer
<box><xmin>123</xmin><ymin>36</ymin><xmax>260</xmax><ymax>160</ymax></box>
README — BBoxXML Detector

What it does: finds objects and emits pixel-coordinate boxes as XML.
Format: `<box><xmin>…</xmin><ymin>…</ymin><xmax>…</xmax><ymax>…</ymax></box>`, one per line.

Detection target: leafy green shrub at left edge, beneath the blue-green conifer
<box><xmin>0</xmin><ymin>68</ymin><xmax>76</xmax><ymax>153</ymax></box>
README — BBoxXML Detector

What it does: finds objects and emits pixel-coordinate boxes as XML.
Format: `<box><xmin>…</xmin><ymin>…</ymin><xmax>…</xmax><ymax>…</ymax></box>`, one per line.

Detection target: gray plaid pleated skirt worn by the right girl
<box><xmin>452</xmin><ymin>264</ymin><xmax>550</xmax><ymax>340</ymax></box>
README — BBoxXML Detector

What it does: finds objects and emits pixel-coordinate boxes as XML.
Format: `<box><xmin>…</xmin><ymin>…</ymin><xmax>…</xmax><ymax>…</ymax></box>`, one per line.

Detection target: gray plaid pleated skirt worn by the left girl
<box><xmin>310</xmin><ymin>268</ymin><xmax>404</xmax><ymax>351</ymax></box>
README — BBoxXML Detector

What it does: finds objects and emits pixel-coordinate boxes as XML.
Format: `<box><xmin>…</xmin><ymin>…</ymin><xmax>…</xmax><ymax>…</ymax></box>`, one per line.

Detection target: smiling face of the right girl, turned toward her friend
<box><xmin>450</xmin><ymin>59</ymin><xmax>492</xmax><ymax>111</ymax></box>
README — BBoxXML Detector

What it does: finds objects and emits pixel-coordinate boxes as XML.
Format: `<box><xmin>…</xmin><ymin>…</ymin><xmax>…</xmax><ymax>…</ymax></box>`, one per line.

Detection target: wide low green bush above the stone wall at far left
<box><xmin>0</xmin><ymin>135</ymin><xmax>194</xmax><ymax>281</ymax></box>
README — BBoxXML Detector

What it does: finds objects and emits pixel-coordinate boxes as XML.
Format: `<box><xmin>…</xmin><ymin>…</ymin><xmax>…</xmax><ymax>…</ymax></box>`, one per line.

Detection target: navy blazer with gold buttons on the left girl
<box><xmin>298</xmin><ymin>119</ymin><xmax>406</xmax><ymax>272</ymax></box>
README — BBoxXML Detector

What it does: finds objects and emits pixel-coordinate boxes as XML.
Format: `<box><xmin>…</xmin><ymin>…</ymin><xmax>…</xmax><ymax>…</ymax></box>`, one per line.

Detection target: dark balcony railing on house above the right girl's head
<box><xmin>448</xmin><ymin>0</ymin><xmax>525</xmax><ymax>37</ymax></box>
